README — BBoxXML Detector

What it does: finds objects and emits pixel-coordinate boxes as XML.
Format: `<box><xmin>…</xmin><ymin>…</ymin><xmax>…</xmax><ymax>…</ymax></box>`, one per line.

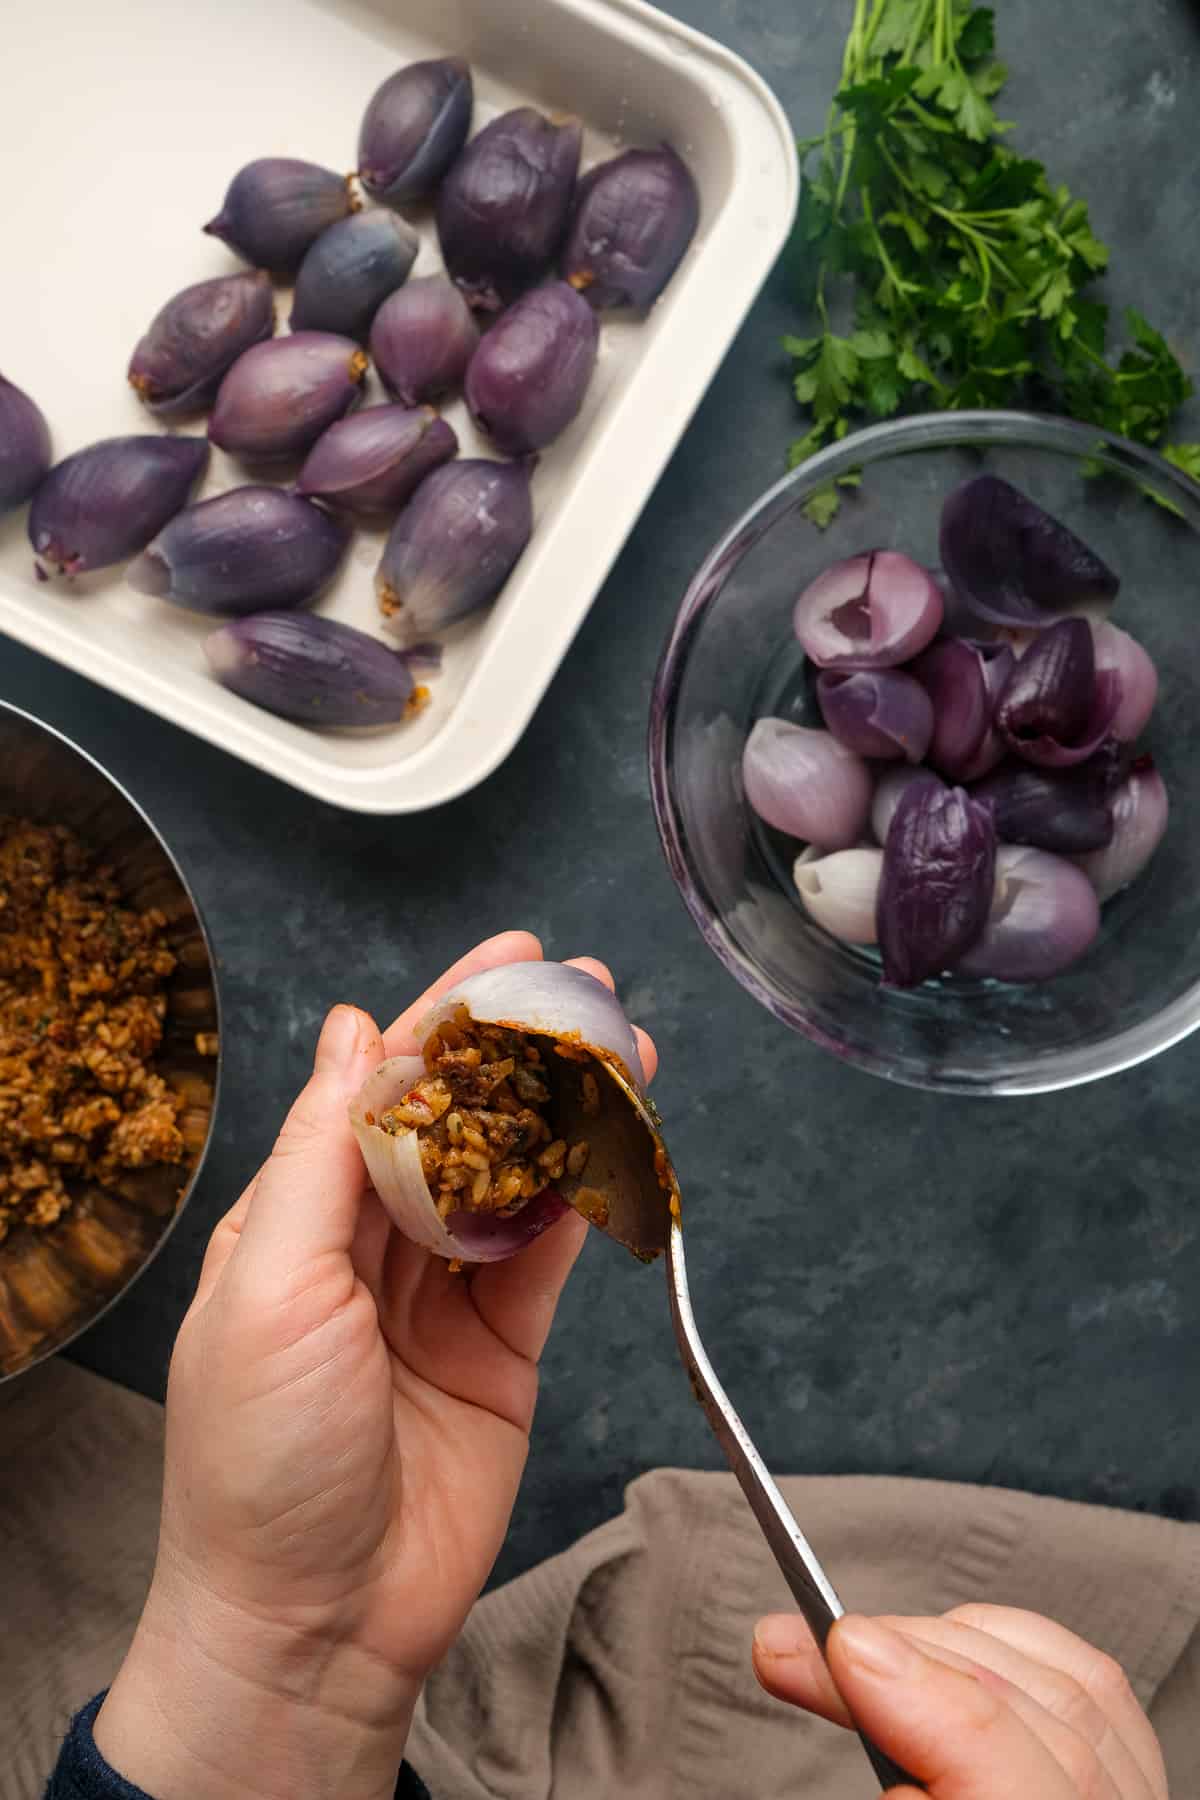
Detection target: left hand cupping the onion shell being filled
<box><xmin>95</xmin><ymin>932</ymin><xmax>657</xmax><ymax>1800</ymax></box>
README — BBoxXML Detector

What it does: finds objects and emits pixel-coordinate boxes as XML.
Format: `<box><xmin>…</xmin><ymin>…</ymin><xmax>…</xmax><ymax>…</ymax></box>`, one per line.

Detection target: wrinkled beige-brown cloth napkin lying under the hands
<box><xmin>0</xmin><ymin>1359</ymin><xmax>1200</xmax><ymax>1800</ymax></box>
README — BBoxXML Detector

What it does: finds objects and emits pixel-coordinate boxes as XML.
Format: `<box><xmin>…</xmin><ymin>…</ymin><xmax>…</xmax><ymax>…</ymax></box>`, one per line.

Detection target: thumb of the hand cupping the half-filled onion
<box><xmin>234</xmin><ymin>1006</ymin><xmax>383</xmax><ymax>1282</ymax></box>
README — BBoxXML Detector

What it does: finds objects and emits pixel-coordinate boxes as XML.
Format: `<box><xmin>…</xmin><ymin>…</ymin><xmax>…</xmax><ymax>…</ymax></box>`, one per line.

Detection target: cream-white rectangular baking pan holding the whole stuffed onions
<box><xmin>0</xmin><ymin>0</ymin><xmax>795</xmax><ymax>814</ymax></box>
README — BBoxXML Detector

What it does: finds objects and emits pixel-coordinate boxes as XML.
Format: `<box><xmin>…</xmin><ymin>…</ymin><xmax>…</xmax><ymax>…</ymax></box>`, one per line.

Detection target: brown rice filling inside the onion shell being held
<box><xmin>380</xmin><ymin>1006</ymin><xmax>594</xmax><ymax>1219</ymax></box>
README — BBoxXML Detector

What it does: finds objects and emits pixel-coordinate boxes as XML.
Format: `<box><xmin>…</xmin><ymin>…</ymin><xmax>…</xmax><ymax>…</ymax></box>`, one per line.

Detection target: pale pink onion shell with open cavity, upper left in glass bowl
<box><xmin>792</xmin><ymin>551</ymin><xmax>945</xmax><ymax>670</ymax></box>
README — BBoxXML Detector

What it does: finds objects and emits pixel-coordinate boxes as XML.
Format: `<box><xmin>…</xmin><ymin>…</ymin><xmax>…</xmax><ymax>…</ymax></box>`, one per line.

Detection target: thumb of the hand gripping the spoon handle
<box><xmin>828</xmin><ymin>1615</ymin><xmax>1078</xmax><ymax>1800</ymax></box>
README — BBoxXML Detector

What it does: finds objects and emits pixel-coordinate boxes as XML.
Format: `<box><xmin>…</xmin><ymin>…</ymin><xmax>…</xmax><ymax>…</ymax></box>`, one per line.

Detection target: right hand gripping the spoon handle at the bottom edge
<box><xmin>754</xmin><ymin>1606</ymin><xmax>1168</xmax><ymax>1800</ymax></box>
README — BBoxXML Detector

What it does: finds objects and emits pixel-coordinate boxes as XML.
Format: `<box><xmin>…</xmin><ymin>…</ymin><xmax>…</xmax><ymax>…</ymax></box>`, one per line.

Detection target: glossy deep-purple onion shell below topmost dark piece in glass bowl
<box><xmin>995</xmin><ymin>619</ymin><xmax>1121</xmax><ymax>769</ymax></box>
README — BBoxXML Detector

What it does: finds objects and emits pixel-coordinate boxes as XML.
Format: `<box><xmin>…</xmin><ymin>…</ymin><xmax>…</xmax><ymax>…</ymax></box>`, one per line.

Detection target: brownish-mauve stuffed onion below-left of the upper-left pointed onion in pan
<box><xmin>130</xmin><ymin>270</ymin><xmax>275</xmax><ymax>418</ymax></box>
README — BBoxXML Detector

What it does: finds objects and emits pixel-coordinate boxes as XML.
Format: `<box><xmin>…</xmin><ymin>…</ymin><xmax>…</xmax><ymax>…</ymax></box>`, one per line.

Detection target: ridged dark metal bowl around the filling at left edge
<box><xmin>0</xmin><ymin>700</ymin><xmax>219</xmax><ymax>1382</ymax></box>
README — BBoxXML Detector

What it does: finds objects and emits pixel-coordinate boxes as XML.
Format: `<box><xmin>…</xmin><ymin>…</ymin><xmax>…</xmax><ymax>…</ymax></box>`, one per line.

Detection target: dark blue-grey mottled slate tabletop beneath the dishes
<box><xmin>0</xmin><ymin>0</ymin><xmax>1200</xmax><ymax>1573</ymax></box>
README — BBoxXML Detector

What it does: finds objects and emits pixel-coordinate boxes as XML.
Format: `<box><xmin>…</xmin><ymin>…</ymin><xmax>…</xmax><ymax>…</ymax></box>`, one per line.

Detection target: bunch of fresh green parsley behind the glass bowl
<box><xmin>784</xmin><ymin>0</ymin><xmax>1200</xmax><ymax>524</ymax></box>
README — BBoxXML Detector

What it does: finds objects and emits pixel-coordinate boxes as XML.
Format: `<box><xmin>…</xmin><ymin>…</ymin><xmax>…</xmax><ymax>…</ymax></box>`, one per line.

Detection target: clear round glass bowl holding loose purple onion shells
<box><xmin>649</xmin><ymin>412</ymin><xmax>1200</xmax><ymax>1094</ymax></box>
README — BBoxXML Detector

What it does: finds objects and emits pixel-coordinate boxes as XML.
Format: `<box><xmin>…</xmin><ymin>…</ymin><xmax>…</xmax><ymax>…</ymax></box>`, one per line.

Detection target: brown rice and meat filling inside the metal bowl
<box><xmin>0</xmin><ymin>815</ymin><xmax>185</xmax><ymax>1238</ymax></box>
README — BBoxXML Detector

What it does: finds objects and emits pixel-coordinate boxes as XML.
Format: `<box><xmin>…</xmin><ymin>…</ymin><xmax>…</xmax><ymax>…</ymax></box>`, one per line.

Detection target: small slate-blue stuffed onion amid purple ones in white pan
<box><xmin>291</xmin><ymin>209</ymin><xmax>421</xmax><ymax>344</ymax></box>
